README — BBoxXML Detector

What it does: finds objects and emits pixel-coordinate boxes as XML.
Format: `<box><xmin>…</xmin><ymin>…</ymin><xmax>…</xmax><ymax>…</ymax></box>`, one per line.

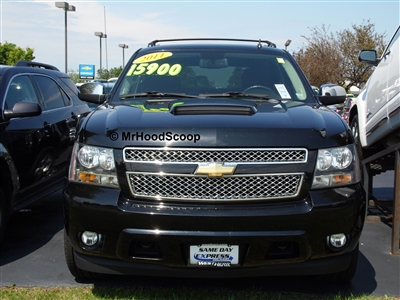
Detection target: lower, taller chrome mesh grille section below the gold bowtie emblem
<box><xmin>127</xmin><ymin>172</ymin><xmax>303</xmax><ymax>202</ymax></box>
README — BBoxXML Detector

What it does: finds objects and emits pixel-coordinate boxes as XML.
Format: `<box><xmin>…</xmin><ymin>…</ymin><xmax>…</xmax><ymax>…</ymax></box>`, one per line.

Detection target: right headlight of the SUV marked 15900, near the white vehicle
<box><xmin>312</xmin><ymin>145</ymin><xmax>361</xmax><ymax>189</ymax></box>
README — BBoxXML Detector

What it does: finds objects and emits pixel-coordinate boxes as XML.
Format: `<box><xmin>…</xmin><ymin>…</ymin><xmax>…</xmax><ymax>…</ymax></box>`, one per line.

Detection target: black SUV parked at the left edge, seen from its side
<box><xmin>0</xmin><ymin>61</ymin><xmax>90</xmax><ymax>237</ymax></box>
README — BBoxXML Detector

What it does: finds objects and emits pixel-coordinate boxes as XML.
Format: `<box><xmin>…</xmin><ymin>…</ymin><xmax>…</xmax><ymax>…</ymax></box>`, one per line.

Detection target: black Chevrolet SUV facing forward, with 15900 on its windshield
<box><xmin>63</xmin><ymin>39</ymin><xmax>366</xmax><ymax>281</ymax></box>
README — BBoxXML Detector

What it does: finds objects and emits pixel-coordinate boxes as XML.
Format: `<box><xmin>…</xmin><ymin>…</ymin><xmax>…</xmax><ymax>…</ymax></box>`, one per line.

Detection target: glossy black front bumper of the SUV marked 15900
<box><xmin>64</xmin><ymin>183</ymin><xmax>366</xmax><ymax>277</ymax></box>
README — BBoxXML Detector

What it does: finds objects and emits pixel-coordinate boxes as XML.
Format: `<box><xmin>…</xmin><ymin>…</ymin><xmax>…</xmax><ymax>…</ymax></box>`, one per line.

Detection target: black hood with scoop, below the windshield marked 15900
<box><xmin>78</xmin><ymin>99</ymin><xmax>352</xmax><ymax>150</ymax></box>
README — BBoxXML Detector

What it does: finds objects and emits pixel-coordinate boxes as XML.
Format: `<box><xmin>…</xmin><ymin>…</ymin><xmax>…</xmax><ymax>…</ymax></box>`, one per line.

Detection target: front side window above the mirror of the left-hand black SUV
<box><xmin>4</xmin><ymin>75</ymin><xmax>39</xmax><ymax>109</ymax></box>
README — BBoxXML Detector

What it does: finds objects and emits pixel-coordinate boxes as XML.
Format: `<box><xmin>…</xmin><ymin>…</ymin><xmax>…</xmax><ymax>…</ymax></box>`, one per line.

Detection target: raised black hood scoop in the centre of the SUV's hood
<box><xmin>170</xmin><ymin>103</ymin><xmax>257</xmax><ymax>116</ymax></box>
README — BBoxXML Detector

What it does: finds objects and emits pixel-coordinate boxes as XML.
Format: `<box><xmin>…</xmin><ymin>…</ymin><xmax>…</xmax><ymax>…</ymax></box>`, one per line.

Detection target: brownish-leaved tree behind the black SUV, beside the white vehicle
<box><xmin>293</xmin><ymin>20</ymin><xmax>385</xmax><ymax>91</ymax></box>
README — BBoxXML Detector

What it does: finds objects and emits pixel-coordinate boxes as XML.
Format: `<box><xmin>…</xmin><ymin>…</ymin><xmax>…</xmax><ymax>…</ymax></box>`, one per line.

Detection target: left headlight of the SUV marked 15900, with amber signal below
<box><xmin>69</xmin><ymin>143</ymin><xmax>119</xmax><ymax>188</ymax></box>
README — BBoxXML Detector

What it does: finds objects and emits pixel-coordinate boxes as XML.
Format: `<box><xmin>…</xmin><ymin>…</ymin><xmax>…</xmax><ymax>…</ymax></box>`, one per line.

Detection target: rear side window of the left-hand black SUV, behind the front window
<box><xmin>35</xmin><ymin>76</ymin><xmax>70</xmax><ymax>110</ymax></box>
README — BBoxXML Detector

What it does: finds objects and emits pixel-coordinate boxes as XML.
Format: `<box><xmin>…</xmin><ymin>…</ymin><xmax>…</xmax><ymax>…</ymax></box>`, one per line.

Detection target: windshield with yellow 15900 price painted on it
<box><xmin>116</xmin><ymin>50</ymin><xmax>307</xmax><ymax>101</ymax></box>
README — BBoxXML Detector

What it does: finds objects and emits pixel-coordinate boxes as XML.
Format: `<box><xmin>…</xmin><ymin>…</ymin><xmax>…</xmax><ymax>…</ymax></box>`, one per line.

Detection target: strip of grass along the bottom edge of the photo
<box><xmin>0</xmin><ymin>286</ymin><xmax>396</xmax><ymax>300</ymax></box>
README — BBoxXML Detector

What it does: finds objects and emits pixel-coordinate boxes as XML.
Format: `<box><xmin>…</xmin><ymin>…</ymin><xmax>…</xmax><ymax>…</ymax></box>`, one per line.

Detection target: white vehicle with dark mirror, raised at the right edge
<box><xmin>349</xmin><ymin>26</ymin><xmax>400</xmax><ymax>156</ymax></box>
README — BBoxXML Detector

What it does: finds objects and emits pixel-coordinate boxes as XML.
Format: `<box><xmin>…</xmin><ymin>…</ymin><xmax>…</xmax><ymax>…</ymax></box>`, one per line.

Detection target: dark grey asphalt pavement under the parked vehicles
<box><xmin>0</xmin><ymin>171</ymin><xmax>400</xmax><ymax>298</ymax></box>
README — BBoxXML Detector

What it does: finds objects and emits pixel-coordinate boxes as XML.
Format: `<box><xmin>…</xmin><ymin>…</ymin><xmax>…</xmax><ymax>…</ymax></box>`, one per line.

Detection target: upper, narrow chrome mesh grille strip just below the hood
<box><xmin>124</xmin><ymin>148</ymin><xmax>308</xmax><ymax>163</ymax></box>
